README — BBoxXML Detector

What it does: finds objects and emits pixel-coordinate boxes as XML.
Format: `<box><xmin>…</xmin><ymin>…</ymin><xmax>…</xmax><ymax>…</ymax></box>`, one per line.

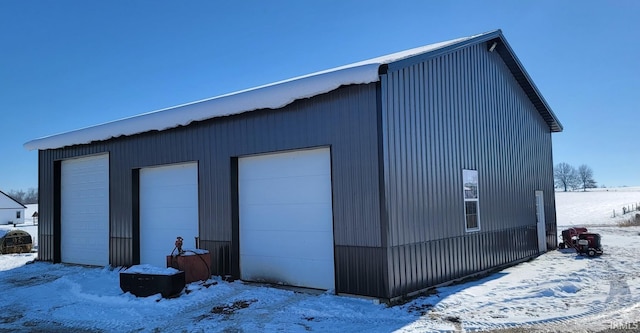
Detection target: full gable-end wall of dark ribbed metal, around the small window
<box><xmin>381</xmin><ymin>43</ymin><xmax>556</xmax><ymax>297</ymax></box>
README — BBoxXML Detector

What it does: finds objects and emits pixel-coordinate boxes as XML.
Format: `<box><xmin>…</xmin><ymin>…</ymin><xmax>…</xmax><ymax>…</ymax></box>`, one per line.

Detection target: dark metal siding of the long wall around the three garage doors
<box><xmin>39</xmin><ymin>83</ymin><xmax>387</xmax><ymax>296</ymax></box>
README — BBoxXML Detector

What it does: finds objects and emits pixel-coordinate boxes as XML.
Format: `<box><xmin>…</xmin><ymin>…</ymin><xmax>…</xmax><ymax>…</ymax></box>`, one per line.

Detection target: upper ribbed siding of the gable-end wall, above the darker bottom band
<box><xmin>382</xmin><ymin>41</ymin><xmax>553</xmax><ymax>245</ymax></box>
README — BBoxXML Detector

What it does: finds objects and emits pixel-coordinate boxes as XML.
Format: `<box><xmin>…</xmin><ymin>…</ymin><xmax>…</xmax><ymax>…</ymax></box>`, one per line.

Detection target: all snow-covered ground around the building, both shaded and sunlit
<box><xmin>0</xmin><ymin>189</ymin><xmax>640</xmax><ymax>332</ymax></box>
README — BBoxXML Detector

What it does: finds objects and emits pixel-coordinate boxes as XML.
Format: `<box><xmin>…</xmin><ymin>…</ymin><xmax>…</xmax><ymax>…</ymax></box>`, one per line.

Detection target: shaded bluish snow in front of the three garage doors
<box><xmin>0</xmin><ymin>256</ymin><xmax>415</xmax><ymax>332</ymax></box>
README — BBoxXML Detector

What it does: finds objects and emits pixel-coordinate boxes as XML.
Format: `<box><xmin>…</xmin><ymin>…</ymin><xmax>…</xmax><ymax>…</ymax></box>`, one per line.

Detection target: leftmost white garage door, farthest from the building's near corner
<box><xmin>60</xmin><ymin>154</ymin><xmax>109</xmax><ymax>266</ymax></box>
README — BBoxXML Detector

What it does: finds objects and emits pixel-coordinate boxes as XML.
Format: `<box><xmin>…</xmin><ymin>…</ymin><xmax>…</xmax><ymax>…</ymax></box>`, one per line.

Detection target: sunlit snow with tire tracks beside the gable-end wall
<box><xmin>405</xmin><ymin>226</ymin><xmax>640</xmax><ymax>332</ymax></box>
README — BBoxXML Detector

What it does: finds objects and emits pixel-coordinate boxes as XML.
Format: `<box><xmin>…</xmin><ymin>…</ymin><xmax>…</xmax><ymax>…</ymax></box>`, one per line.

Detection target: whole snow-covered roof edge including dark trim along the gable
<box><xmin>24</xmin><ymin>30</ymin><xmax>562</xmax><ymax>150</ymax></box>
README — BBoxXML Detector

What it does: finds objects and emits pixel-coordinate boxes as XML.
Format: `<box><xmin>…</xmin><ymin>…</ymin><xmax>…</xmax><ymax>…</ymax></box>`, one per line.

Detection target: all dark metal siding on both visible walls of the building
<box><xmin>39</xmin><ymin>43</ymin><xmax>556</xmax><ymax>298</ymax></box>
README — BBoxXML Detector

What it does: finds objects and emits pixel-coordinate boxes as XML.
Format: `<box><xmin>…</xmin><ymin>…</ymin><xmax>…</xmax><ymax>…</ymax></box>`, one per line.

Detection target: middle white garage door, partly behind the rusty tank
<box><xmin>140</xmin><ymin>163</ymin><xmax>198</xmax><ymax>267</ymax></box>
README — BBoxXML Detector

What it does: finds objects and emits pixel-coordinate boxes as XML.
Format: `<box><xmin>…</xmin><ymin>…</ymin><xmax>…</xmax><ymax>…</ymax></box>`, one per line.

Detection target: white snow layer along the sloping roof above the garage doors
<box><xmin>24</xmin><ymin>36</ymin><xmax>477</xmax><ymax>150</ymax></box>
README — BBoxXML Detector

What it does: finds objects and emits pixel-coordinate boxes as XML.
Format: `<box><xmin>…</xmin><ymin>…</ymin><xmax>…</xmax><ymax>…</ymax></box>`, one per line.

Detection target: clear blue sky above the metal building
<box><xmin>0</xmin><ymin>0</ymin><xmax>640</xmax><ymax>191</ymax></box>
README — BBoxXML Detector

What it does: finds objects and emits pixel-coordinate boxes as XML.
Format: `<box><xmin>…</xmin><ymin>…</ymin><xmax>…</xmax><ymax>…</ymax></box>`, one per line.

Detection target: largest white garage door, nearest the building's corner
<box><xmin>238</xmin><ymin>148</ymin><xmax>335</xmax><ymax>289</ymax></box>
